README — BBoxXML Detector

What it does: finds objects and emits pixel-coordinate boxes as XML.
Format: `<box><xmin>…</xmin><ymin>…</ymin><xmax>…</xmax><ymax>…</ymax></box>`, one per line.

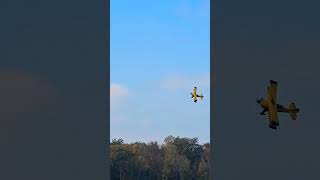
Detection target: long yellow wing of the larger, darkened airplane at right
<box><xmin>267</xmin><ymin>80</ymin><xmax>279</xmax><ymax>126</ymax></box>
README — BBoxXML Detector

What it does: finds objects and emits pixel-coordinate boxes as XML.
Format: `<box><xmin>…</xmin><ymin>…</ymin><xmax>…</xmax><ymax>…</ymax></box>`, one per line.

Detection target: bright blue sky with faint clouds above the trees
<box><xmin>110</xmin><ymin>0</ymin><xmax>210</xmax><ymax>143</ymax></box>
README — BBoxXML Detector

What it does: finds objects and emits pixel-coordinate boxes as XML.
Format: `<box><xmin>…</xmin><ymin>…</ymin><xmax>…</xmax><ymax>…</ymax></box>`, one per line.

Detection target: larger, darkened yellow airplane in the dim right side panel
<box><xmin>257</xmin><ymin>80</ymin><xmax>300</xmax><ymax>129</ymax></box>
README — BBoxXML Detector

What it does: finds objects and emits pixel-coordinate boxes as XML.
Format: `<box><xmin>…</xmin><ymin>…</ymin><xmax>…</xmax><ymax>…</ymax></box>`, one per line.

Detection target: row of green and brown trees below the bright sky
<box><xmin>110</xmin><ymin>136</ymin><xmax>210</xmax><ymax>180</ymax></box>
